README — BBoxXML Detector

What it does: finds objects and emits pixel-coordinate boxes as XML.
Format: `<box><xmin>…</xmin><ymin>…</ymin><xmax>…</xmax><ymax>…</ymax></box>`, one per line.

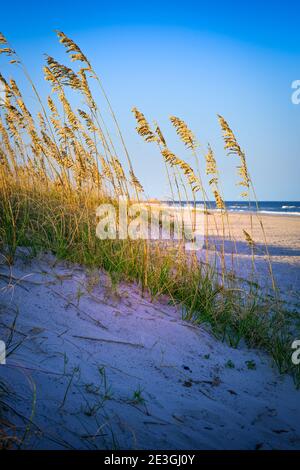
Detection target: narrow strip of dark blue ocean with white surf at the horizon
<box><xmin>165</xmin><ymin>201</ymin><xmax>300</xmax><ymax>216</ymax></box>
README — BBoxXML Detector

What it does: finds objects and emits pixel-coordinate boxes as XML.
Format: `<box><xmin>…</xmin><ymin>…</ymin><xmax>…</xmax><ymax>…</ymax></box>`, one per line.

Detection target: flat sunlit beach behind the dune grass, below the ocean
<box><xmin>151</xmin><ymin>203</ymin><xmax>300</xmax><ymax>304</ymax></box>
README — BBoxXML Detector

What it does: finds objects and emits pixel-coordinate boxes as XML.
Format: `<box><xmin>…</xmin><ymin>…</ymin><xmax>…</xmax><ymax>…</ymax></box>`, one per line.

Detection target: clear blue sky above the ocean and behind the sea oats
<box><xmin>0</xmin><ymin>0</ymin><xmax>300</xmax><ymax>200</ymax></box>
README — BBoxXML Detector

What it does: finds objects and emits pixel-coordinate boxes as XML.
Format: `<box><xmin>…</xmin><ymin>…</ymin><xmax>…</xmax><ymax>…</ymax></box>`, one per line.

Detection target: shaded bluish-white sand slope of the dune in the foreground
<box><xmin>0</xmin><ymin>252</ymin><xmax>300</xmax><ymax>449</ymax></box>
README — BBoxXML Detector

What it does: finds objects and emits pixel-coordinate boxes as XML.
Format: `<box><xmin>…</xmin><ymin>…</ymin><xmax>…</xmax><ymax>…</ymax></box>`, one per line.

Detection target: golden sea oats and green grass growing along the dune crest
<box><xmin>0</xmin><ymin>32</ymin><xmax>300</xmax><ymax>392</ymax></box>
